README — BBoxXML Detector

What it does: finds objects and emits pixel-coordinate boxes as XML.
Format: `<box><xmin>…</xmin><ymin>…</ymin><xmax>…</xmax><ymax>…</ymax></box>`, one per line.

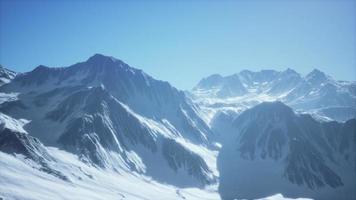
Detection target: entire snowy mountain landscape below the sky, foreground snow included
<box><xmin>0</xmin><ymin>54</ymin><xmax>356</xmax><ymax>199</ymax></box>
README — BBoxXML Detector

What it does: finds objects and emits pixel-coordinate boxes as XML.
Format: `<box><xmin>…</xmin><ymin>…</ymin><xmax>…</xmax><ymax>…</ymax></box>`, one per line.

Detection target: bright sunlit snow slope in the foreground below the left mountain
<box><xmin>0</xmin><ymin>148</ymin><xmax>310</xmax><ymax>200</ymax></box>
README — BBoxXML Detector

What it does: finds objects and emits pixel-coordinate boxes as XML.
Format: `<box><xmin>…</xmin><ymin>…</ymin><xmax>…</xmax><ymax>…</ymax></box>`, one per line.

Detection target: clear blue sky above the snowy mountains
<box><xmin>0</xmin><ymin>0</ymin><xmax>356</xmax><ymax>89</ymax></box>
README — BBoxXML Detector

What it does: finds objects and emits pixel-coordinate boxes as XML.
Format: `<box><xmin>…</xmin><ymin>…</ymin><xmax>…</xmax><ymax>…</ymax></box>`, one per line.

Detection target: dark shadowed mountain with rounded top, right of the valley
<box><xmin>218</xmin><ymin>102</ymin><xmax>356</xmax><ymax>199</ymax></box>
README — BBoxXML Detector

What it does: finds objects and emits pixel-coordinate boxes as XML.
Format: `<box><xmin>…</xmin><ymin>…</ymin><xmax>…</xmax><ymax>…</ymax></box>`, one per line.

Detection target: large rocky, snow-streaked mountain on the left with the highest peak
<box><xmin>0</xmin><ymin>54</ymin><xmax>218</xmax><ymax>191</ymax></box>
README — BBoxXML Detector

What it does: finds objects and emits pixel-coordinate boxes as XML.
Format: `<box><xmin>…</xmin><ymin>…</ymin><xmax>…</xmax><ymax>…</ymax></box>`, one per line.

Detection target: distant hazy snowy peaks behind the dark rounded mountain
<box><xmin>190</xmin><ymin>69</ymin><xmax>356</xmax><ymax>123</ymax></box>
